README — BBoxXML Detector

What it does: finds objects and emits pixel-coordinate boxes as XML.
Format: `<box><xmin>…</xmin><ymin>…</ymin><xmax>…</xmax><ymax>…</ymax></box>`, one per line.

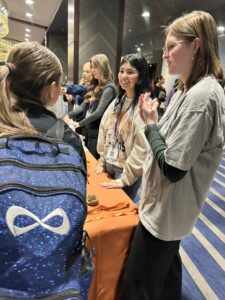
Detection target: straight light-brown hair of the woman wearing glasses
<box><xmin>165</xmin><ymin>11</ymin><xmax>224</xmax><ymax>89</ymax></box>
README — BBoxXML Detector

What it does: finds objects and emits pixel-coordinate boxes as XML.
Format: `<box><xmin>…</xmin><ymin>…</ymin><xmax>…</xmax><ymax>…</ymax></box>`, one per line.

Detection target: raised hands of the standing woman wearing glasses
<box><xmin>138</xmin><ymin>93</ymin><xmax>159</xmax><ymax>125</ymax></box>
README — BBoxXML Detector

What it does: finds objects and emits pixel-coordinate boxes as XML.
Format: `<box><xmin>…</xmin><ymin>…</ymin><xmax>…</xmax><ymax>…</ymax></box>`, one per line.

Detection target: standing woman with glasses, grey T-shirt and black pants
<box><xmin>120</xmin><ymin>11</ymin><xmax>225</xmax><ymax>300</ymax></box>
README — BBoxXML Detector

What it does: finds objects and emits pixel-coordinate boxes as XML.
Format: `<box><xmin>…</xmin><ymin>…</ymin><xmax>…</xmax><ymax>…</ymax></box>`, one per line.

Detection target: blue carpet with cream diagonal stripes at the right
<box><xmin>180</xmin><ymin>151</ymin><xmax>225</xmax><ymax>300</ymax></box>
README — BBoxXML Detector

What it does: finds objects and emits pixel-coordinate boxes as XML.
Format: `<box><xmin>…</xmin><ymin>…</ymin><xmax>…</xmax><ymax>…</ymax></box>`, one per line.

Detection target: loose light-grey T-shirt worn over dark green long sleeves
<box><xmin>139</xmin><ymin>77</ymin><xmax>225</xmax><ymax>241</ymax></box>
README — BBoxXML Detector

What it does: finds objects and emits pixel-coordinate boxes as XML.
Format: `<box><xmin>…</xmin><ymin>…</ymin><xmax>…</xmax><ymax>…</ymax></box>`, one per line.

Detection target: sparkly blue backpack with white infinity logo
<box><xmin>0</xmin><ymin>135</ymin><xmax>92</xmax><ymax>300</ymax></box>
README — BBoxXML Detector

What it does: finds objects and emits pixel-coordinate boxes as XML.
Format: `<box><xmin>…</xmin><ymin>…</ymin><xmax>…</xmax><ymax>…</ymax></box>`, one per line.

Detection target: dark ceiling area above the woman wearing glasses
<box><xmin>123</xmin><ymin>0</ymin><xmax>225</xmax><ymax>52</ymax></box>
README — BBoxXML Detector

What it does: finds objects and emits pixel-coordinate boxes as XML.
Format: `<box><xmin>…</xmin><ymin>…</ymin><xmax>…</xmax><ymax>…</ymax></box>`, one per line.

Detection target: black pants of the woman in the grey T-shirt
<box><xmin>119</xmin><ymin>222</ymin><xmax>182</xmax><ymax>300</ymax></box>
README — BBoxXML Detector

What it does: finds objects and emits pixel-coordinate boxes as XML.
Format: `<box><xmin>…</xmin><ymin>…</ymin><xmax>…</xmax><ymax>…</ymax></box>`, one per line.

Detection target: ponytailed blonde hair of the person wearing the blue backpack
<box><xmin>0</xmin><ymin>42</ymin><xmax>62</xmax><ymax>136</ymax></box>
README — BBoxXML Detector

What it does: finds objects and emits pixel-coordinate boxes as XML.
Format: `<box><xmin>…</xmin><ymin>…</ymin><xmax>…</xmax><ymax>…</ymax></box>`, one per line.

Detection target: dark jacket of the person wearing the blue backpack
<box><xmin>26</xmin><ymin>104</ymin><xmax>86</xmax><ymax>167</ymax></box>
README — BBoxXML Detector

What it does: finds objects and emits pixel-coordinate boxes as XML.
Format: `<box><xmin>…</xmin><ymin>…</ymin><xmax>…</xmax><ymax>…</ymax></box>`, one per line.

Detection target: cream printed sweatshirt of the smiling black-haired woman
<box><xmin>97</xmin><ymin>97</ymin><xmax>149</xmax><ymax>186</ymax></box>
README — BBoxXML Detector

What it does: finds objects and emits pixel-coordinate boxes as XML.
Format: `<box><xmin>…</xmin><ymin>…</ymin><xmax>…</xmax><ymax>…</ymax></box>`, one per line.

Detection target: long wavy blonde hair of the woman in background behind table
<box><xmin>85</xmin><ymin>54</ymin><xmax>113</xmax><ymax>102</ymax></box>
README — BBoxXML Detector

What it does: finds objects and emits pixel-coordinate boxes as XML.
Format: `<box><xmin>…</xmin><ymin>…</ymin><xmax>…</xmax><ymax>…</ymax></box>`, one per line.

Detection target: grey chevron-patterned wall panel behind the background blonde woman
<box><xmin>79</xmin><ymin>0</ymin><xmax>120</xmax><ymax>80</ymax></box>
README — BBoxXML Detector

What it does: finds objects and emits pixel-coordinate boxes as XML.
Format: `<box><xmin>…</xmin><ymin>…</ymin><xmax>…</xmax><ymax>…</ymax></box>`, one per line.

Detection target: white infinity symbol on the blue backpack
<box><xmin>6</xmin><ymin>205</ymin><xmax>70</xmax><ymax>237</ymax></box>
